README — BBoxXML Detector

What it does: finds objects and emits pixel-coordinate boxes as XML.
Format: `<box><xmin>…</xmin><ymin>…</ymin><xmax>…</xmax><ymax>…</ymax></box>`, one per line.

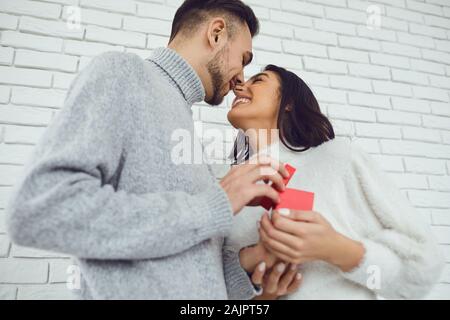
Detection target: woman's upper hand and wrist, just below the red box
<box><xmin>259</xmin><ymin>209</ymin><xmax>365</xmax><ymax>271</ymax></box>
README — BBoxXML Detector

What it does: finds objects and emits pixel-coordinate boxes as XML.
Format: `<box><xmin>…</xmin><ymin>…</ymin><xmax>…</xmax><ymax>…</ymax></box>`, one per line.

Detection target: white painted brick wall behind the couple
<box><xmin>0</xmin><ymin>0</ymin><xmax>450</xmax><ymax>299</ymax></box>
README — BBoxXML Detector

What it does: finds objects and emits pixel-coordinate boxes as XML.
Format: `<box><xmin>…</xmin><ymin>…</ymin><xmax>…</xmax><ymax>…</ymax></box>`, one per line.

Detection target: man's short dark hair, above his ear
<box><xmin>169</xmin><ymin>0</ymin><xmax>259</xmax><ymax>42</ymax></box>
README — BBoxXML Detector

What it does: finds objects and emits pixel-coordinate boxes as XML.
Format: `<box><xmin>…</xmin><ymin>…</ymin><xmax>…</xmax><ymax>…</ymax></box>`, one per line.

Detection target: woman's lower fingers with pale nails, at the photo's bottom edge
<box><xmin>252</xmin><ymin>262</ymin><xmax>302</xmax><ymax>300</ymax></box>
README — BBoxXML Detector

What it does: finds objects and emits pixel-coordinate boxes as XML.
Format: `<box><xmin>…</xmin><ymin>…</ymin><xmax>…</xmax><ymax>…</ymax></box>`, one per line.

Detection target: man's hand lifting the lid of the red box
<box><xmin>220</xmin><ymin>157</ymin><xmax>289</xmax><ymax>214</ymax></box>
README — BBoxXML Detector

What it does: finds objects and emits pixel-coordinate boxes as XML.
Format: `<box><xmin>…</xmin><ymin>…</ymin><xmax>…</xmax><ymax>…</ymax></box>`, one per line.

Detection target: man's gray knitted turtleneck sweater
<box><xmin>7</xmin><ymin>48</ymin><xmax>254</xmax><ymax>299</ymax></box>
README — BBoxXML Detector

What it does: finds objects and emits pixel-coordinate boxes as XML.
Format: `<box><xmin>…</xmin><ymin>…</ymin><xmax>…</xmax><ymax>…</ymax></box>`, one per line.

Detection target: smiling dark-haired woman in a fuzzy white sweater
<box><xmin>228</xmin><ymin>65</ymin><xmax>443</xmax><ymax>299</ymax></box>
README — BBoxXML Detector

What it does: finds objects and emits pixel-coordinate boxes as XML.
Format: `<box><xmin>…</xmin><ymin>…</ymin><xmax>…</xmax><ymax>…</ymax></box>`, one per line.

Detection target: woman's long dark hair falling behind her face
<box><xmin>233</xmin><ymin>64</ymin><xmax>335</xmax><ymax>163</ymax></box>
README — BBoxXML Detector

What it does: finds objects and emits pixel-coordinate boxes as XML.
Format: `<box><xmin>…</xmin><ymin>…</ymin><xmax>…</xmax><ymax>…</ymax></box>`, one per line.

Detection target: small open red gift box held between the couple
<box><xmin>261</xmin><ymin>164</ymin><xmax>314</xmax><ymax>211</ymax></box>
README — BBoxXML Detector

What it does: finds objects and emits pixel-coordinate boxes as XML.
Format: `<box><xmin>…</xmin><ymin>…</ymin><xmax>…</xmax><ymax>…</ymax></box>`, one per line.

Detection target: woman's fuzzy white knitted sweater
<box><xmin>228</xmin><ymin>138</ymin><xmax>443</xmax><ymax>300</ymax></box>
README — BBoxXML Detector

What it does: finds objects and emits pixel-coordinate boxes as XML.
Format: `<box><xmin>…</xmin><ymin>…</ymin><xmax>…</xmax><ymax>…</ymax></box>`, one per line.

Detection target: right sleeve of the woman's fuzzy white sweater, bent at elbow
<box><xmin>342</xmin><ymin>145</ymin><xmax>443</xmax><ymax>299</ymax></box>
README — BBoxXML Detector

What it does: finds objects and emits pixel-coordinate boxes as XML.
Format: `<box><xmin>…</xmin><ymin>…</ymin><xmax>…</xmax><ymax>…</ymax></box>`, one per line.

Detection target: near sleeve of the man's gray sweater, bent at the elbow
<box><xmin>7</xmin><ymin>53</ymin><xmax>232</xmax><ymax>260</ymax></box>
